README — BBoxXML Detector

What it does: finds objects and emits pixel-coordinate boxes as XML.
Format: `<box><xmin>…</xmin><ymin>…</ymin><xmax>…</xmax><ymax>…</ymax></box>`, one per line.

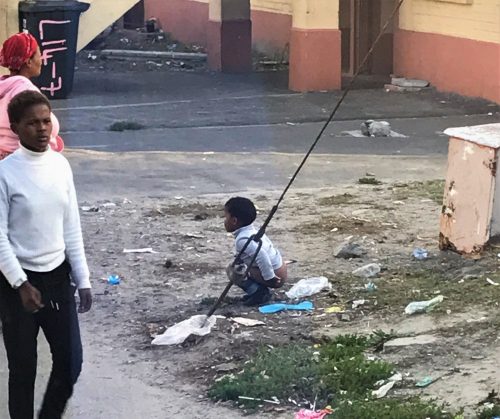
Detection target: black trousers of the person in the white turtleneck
<box><xmin>0</xmin><ymin>262</ymin><xmax>82</xmax><ymax>419</ymax></box>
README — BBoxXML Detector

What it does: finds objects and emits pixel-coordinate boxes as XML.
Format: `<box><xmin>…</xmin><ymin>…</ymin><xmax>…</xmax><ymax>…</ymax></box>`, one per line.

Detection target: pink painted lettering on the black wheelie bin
<box><xmin>38</xmin><ymin>20</ymin><xmax>71</xmax><ymax>97</ymax></box>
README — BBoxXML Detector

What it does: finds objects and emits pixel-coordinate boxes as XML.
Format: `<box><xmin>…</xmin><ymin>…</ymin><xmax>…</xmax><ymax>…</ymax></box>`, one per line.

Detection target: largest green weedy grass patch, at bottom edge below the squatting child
<box><xmin>209</xmin><ymin>332</ymin><xmax>454</xmax><ymax>419</ymax></box>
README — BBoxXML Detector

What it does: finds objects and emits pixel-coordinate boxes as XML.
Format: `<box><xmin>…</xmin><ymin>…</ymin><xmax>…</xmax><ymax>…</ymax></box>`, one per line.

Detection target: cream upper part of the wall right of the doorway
<box><xmin>399</xmin><ymin>0</ymin><xmax>500</xmax><ymax>43</ymax></box>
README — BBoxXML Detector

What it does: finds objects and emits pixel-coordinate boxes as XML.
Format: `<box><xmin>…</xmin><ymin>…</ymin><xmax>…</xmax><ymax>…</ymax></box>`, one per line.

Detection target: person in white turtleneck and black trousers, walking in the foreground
<box><xmin>0</xmin><ymin>91</ymin><xmax>92</xmax><ymax>419</ymax></box>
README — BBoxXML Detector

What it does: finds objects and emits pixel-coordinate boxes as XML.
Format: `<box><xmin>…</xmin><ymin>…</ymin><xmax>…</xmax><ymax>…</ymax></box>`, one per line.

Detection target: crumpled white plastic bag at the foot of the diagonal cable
<box><xmin>151</xmin><ymin>314</ymin><xmax>217</xmax><ymax>345</ymax></box>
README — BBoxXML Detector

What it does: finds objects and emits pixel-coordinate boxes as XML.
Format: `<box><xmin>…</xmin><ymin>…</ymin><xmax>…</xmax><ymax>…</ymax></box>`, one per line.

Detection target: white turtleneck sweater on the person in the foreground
<box><xmin>0</xmin><ymin>146</ymin><xmax>90</xmax><ymax>289</ymax></box>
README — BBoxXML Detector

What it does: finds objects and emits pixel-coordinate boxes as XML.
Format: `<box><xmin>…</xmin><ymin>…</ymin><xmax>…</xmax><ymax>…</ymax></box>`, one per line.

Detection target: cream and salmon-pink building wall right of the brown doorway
<box><xmin>394</xmin><ymin>0</ymin><xmax>500</xmax><ymax>103</ymax></box>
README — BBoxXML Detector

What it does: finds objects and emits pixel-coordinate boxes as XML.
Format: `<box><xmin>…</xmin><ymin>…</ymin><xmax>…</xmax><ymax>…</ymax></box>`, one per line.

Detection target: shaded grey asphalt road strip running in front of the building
<box><xmin>54</xmin><ymin>72</ymin><xmax>500</xmax><ymax>155</ymax></box>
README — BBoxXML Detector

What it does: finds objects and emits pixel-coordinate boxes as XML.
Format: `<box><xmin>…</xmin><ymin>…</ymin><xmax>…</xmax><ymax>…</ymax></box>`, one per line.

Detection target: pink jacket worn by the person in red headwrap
<box><xmin>0</xmin><ymin>76</ymin><xmax>64</xmax><ymax>154</ymax></box>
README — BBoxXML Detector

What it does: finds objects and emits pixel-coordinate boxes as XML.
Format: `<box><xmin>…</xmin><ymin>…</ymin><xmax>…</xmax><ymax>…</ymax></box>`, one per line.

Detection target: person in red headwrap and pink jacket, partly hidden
<box><xmin>0</xmin><ymin>32</ymin><xmax>64</xmax><ymax>160</ymax></box>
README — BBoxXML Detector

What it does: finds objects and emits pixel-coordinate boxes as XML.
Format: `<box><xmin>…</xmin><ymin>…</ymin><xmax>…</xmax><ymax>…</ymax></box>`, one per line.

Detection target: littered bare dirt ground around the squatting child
<box><xmin>82</xmin><ymin>176</ymin><xmax>500</xmax><ymax>417</ymax></box>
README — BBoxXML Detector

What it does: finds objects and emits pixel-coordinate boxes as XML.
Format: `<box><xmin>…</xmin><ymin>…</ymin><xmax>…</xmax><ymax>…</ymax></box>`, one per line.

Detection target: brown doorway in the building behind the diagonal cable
<box><xmin>339</xmin><ymin>0</ymin><xmax>396</xmax><ymax>76</ymax></box>
